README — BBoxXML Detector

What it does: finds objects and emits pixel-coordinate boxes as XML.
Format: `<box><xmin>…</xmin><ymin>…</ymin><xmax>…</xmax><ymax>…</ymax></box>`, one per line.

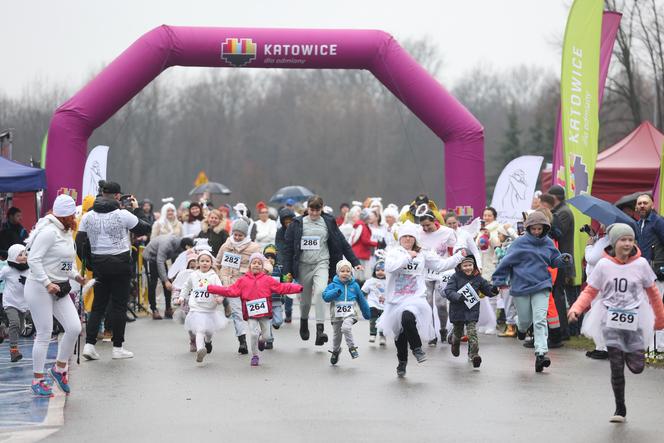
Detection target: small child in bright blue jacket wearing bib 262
<box><xmin>323</xmin><ymin>260</ymin><xmax>371</xmax><ymax>365</ymax></box>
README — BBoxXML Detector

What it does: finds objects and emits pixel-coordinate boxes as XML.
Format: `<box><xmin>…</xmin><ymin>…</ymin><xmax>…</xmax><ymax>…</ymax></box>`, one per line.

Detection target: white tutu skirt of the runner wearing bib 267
<box><xmin>376</xmin><ymin>297</ymin><xmax>436</xmax><ymax>342</ymax></box>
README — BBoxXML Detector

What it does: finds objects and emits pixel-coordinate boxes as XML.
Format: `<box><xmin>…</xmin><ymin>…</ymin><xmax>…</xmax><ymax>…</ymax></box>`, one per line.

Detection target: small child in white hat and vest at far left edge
<box><xmin>0</xmin><ymin>244</ymin><xmax>29</xmax><ymax>363</ymax></box>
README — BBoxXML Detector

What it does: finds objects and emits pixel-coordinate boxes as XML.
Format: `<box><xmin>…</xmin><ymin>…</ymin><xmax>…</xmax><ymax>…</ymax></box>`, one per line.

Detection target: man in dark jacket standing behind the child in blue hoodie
<box><xmin>548</xmin><ymin>185</ymin><xmax>581</xmax><ymax>340</ymax></box>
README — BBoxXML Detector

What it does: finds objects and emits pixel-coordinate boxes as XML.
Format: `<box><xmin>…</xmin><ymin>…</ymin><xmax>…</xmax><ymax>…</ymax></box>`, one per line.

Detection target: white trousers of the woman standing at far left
<box><xmin>25</xmin><ymin>279</ymin><xmax>81</xmax><ymax>374</ymax></box>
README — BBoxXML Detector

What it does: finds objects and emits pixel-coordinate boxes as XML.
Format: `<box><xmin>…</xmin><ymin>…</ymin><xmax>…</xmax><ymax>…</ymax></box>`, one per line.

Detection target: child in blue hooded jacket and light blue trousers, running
<box><xmin>493</xmin><ymin>211</ymin><xmax>572</xmax><ymax>372</ymax></box>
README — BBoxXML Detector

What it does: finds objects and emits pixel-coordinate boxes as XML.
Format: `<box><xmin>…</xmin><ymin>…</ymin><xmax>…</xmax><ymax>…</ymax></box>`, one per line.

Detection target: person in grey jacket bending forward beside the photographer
<box><xmin>143</xmin><ymin>234</ymin><xmax>194</xmax><ymax>320</ymax></box>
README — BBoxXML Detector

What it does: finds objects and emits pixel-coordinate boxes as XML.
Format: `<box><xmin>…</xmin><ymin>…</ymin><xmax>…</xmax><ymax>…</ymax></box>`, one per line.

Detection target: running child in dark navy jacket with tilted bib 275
<box><xmin>445</xmin><ymin>250</ymin><xmax>498</xmax><ymax>368</ymax></box>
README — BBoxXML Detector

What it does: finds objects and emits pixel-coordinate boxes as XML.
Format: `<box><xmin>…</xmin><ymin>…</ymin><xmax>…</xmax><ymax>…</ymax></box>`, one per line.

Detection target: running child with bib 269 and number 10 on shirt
<box><xmin>567</xmin><ymin>223</ymin><xmax>664</xmax><ymax>423</ymax></box>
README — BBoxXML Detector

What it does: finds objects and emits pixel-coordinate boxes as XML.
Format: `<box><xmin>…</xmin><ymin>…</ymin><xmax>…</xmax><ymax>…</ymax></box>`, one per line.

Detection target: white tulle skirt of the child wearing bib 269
<box><xmin>581</xmin><ymin>300</ymin><xmax>655</xmax><ymax>352</ymax></box>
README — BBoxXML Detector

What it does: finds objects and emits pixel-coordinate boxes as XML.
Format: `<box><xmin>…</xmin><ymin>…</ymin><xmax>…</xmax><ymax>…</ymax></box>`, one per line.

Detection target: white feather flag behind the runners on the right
<box><xmin>491</xmin><ymin>155</ymin><xmax>544</xmax><ymax>224</ymax></box>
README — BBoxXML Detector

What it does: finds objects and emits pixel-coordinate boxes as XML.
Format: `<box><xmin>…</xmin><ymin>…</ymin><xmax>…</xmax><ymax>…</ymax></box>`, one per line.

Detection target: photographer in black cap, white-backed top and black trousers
<box><xmin>76</xmin><ymin>181</ymin><xmax>150</xmax><ymax>360</ymax></box>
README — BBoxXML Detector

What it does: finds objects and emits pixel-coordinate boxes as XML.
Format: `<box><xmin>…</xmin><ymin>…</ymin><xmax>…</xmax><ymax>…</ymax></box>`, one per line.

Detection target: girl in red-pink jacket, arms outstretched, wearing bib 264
<box><xmin>207</xmin><ymin>252</ymin><xmax>302</xmax><ymax>366</ymax></box>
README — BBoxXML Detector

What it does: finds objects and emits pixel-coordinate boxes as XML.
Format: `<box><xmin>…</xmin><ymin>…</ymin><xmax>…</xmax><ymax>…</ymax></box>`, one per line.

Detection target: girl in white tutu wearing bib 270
<box><xmin>178</xmin><ymin>251</ymin><xmax>227</xmax><ymax>363</ymax></box>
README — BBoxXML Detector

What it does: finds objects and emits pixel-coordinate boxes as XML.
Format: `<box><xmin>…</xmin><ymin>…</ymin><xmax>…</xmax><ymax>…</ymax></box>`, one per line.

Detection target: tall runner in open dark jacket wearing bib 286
<box><xmin>282</xmin><ymin>195</ymin><xmax>363</xmax><ymax>346</ymax></box>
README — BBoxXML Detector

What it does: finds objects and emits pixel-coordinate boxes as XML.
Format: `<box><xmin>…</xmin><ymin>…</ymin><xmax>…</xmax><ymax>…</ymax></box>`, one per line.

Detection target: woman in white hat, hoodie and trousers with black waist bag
<box><xmin>25</xmin><ymin>195</ymin><xmax>85</xmax><ymax>397</ymax></box>
